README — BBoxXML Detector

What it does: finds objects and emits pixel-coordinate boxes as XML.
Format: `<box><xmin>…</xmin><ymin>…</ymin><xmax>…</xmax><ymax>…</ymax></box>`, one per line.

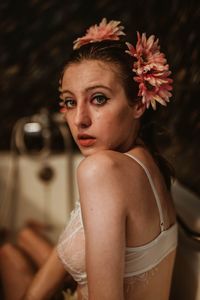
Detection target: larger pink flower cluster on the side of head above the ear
<box><xmin>126</xmin><ymin>32</ymin><xmax>173</xmax><ymax>110</ymax></box>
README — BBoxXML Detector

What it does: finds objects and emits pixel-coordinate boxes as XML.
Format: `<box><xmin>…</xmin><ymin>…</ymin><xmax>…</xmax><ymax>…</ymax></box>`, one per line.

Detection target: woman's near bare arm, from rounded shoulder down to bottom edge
<box><xmin>78</xmin><ymin>151</ymin><xmax>126</xmax><ymax>300</ymax></box>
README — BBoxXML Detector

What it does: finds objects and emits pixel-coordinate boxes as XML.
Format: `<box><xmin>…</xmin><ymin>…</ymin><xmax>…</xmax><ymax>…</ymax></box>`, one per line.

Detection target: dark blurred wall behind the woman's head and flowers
<box><xmin>0</xmin><ymin>0</ymin><xmax>200</xmax><ymax>195</ymax></box>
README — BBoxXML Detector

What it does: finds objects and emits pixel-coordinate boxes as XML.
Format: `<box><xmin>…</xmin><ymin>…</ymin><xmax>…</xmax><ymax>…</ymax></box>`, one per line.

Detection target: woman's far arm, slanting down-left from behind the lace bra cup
<box><xmin>23</xmin><ymin>248</ymin><xmax>66</xmax><ymax>300</ymax></box>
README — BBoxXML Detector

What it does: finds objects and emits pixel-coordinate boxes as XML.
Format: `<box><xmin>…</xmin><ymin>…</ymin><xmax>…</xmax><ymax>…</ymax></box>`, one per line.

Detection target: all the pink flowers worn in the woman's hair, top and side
<box><xmin>73</xmin><ymin>18</ymin><xmax>173</xmax><ymax>110</ymax></box>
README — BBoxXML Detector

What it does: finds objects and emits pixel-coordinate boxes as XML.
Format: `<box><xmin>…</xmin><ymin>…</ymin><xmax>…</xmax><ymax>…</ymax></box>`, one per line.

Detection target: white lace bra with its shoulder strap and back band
<box><xmin>57</xmin><ymin>154</ymin><xmax>177</xmax><ymax>299</ymax></box>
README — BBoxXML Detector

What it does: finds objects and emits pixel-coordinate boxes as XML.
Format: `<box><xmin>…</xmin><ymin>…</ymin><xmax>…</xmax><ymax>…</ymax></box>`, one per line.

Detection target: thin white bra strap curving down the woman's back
<box><xmin>125</xmin><ymin>153</ymin><xmax>164</xmax><ymax>231</ymax></box>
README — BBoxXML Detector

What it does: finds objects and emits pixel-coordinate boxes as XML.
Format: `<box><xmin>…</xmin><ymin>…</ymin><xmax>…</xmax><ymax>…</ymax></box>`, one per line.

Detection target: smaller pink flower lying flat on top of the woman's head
<box><xmin>73</xmin><ymin>18</ymin><xmax>125</xmax><ymax>49</ymax></box>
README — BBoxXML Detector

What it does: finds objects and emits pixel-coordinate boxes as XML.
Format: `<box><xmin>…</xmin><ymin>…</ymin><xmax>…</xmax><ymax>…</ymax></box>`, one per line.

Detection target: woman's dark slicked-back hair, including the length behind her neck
<box><xmin>60</xmin><ymin>40</ymin><xmax>174</xmax><ymax>189</ymax></box>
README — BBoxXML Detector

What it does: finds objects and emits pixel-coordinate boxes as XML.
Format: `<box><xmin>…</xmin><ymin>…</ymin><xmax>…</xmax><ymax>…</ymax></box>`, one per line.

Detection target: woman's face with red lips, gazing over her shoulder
<box><xmin>61</xmin><ymin>60</ymin><xmax>138</xmax><ymax>156</ymax></box>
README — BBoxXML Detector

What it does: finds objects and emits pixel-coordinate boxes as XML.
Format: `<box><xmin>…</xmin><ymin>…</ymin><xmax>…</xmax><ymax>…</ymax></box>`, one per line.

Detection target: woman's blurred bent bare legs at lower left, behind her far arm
<box><xmin>0</xmin><ymin>227</ymin><xmax>76</xmax><ymax>300</ymax></box>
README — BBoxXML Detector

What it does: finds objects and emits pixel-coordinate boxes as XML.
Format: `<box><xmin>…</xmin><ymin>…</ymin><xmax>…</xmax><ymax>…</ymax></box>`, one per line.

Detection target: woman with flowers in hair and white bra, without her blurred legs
<box><xmin>0</xmin><ymin>19</ymin><xmax>177</xmax><ymax>300</ymax></box>
